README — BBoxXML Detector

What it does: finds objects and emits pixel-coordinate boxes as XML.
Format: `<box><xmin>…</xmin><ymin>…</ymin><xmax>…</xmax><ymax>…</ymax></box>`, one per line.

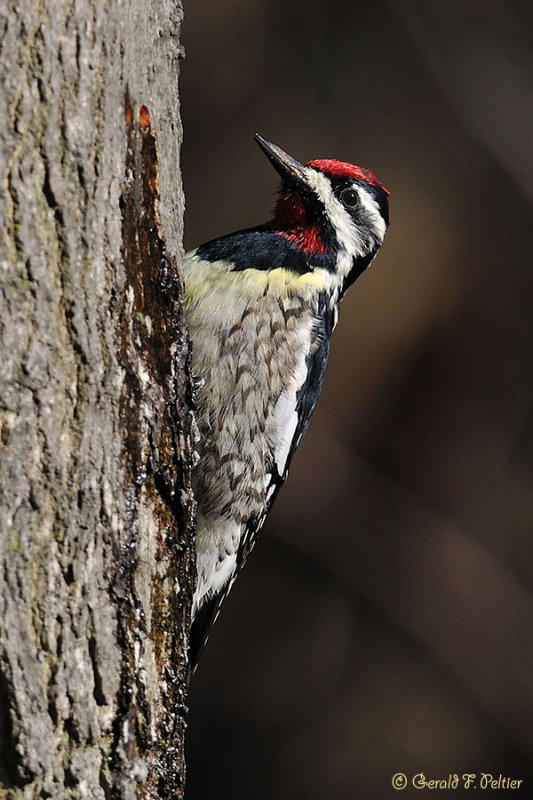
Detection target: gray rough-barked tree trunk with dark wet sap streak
<box><xmin>0</xmin><ymin>0</ymin><xmax>194</xmax><ymax>800</ymax></box>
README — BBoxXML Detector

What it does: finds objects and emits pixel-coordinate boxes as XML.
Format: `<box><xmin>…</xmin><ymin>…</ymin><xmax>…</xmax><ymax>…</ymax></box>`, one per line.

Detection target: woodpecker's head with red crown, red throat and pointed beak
<box><xmin>255</xmin><ymin>134</ymin><xmax>389</xmax><ymax>293</ymax></box>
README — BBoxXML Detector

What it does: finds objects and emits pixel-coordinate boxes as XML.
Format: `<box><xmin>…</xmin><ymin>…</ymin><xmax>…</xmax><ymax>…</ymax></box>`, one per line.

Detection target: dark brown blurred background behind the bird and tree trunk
<box><xmin>182</xmin><ymin>0</ymin><xmax>533</xmax><ymax>800</ymax></box>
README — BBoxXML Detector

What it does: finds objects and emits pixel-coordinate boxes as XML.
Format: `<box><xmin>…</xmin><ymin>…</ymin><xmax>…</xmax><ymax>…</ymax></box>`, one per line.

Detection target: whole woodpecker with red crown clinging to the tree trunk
<box><xmin>184</xmin><ymin>134</ymin><xmax>389</xmax><ymax>669</ymax></box>
